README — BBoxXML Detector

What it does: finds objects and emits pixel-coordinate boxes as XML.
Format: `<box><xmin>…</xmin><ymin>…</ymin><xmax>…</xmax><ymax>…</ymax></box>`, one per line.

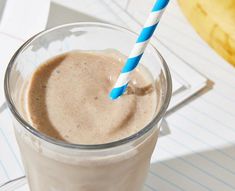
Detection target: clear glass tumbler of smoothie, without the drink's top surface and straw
<box><xmin>5</xmin><ymin>23</ymin><xmax>171</xmax><ymax>191</ymax></box>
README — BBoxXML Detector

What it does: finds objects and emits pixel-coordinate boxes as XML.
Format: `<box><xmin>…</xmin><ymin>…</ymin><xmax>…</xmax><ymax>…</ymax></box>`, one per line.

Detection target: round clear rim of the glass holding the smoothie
<box><xmin>4</xmin><ymin>22</ymin><xmax>172</xmax><ymax>150</ymax></box>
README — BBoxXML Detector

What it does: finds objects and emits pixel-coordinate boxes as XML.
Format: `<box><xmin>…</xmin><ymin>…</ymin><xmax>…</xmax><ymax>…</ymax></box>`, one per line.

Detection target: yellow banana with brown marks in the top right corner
<box><xmin>178</xmin><ymin>0</ymin><xmax>235</xmax><ymax>66</ymax></box>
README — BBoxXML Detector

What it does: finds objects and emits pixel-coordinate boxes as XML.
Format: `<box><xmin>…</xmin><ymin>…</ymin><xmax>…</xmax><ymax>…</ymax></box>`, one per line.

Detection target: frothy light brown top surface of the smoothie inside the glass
<box><xmin>26</xmin><ymin>51</ymin><xmax>156</xmax><ymax>144</ymax></box>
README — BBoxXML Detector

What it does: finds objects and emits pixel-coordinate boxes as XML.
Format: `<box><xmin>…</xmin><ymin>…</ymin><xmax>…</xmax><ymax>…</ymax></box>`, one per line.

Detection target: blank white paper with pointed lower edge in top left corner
<box><xmin>0</xmin><ymin>0</ymin><xmax>50</xmax><ymax>41</ymax></box>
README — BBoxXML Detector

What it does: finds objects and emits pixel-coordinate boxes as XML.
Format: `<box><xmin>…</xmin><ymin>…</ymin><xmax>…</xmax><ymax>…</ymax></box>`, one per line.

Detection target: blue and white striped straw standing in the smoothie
<box><xmin>110</xmin><ymin>0</ymin><xmax>169</xmax><ymax>100</ymax></box>
